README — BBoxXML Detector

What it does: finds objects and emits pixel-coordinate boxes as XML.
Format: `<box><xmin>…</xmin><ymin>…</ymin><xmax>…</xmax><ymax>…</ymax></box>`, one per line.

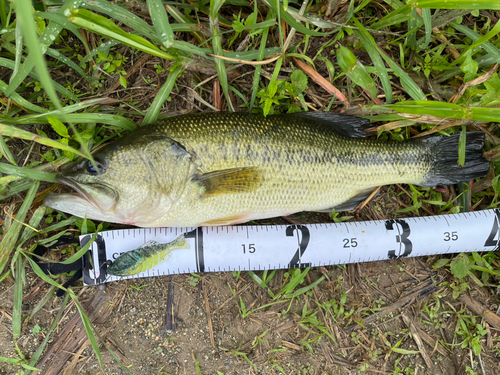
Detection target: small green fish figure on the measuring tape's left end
<box><xmin>106</xmin><ymin>235</ymin><xmax>189</xmax><ymax>276</ymax></box>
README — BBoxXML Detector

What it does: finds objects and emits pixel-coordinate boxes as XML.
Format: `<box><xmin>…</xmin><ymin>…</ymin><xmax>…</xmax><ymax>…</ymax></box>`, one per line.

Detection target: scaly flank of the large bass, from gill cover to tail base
<box><xmin>141</xmin><ymin>115</ymin><xmax>430</xmax><ymax>226</ymax></box>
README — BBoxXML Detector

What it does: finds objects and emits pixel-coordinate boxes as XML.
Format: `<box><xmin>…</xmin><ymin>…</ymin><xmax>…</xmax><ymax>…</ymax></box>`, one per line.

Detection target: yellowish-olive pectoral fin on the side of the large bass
<box><xmin>193</xmin><ymin>167</ymin><xmax>262</xmax><ymax>198</ymax></box>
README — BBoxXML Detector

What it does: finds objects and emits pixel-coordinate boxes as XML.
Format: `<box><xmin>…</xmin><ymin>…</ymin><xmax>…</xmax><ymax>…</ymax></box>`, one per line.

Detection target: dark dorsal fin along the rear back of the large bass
<box><xmin>286</xmin><ymin>111</ymin><xmax>373</xmax><ymax>138</ymax></box>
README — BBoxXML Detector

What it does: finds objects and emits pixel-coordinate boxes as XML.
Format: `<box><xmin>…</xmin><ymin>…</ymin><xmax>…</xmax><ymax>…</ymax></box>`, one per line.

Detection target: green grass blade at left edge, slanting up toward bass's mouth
<box><xmin>0</xmin><ymin>181</ymin><xmax>40</xmax><ymax>275</ymax></box>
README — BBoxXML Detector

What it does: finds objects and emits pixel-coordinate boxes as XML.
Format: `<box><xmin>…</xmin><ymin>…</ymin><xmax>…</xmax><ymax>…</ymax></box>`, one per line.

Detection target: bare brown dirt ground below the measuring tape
<box><xmin>0</xmin><ymin>193</ymin><xmax>500</xmax><ymax>375</ymax></box>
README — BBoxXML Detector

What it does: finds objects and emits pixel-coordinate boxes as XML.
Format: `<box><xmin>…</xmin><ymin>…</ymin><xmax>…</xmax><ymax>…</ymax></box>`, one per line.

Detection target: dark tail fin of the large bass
<box><xmin>422</xmin><ymin>132</ymin><xmax>490</xmax><ymax>186</ymax></box>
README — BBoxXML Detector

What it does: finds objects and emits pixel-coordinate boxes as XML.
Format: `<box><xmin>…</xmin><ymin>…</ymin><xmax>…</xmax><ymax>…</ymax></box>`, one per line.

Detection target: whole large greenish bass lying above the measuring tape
<box><xmin>44</xmin><ymin>112</ymin><xmax>489</xmax><ymax>227</ymax></box>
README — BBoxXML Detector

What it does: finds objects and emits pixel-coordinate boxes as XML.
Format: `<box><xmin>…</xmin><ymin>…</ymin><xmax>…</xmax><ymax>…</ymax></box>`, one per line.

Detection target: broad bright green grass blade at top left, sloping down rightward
<box><xmin>67</xmin><ymin>8</ymin><xmax>175</xmax><ymax>60</ymax></box>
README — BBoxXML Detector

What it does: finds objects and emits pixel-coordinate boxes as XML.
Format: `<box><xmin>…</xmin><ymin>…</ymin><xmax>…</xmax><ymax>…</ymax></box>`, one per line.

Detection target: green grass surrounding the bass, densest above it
<box><xmin>0</xmin><ymin>0</ymin><xmax>500</xmax><ymax>373</ymax></box>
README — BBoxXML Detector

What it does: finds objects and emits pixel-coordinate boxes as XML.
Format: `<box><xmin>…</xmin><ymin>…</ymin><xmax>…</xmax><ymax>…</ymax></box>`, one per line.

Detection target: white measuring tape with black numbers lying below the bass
<box><xmin>80</xmin><ymin>209</ymin><xmax>500</xmax><ymax>285</ymax></box>
